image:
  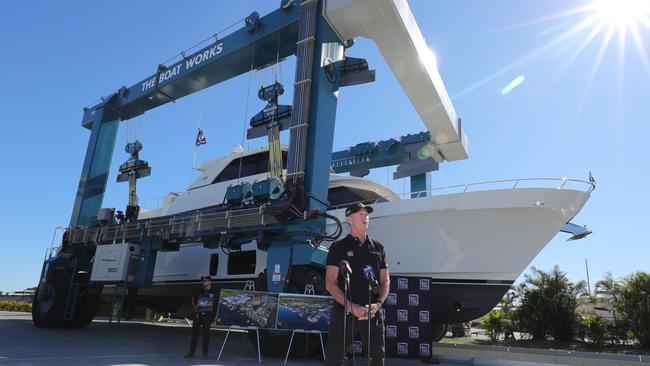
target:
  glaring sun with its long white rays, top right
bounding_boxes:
[452,0,650,102]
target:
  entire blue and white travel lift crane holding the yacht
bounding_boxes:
[32,0,467,354]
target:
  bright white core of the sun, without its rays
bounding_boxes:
[591,0,650,28]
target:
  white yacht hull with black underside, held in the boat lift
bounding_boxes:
[129,188,589,323]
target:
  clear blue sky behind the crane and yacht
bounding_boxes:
[0,0,650,291]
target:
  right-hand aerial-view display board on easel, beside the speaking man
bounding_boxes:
[277,293,334,332]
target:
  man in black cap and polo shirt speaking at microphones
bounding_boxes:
[325,203,390,366]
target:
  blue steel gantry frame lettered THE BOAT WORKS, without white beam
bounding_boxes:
[58,0,374,291]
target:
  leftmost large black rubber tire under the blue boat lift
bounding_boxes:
[32,270,71,328]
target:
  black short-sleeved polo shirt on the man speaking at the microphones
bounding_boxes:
[326,235,388,305]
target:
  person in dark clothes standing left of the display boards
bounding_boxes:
[185,276,217,359]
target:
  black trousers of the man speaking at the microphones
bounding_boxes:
[324,305,386,366]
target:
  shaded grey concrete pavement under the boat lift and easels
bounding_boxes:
[0,312,450,366]
